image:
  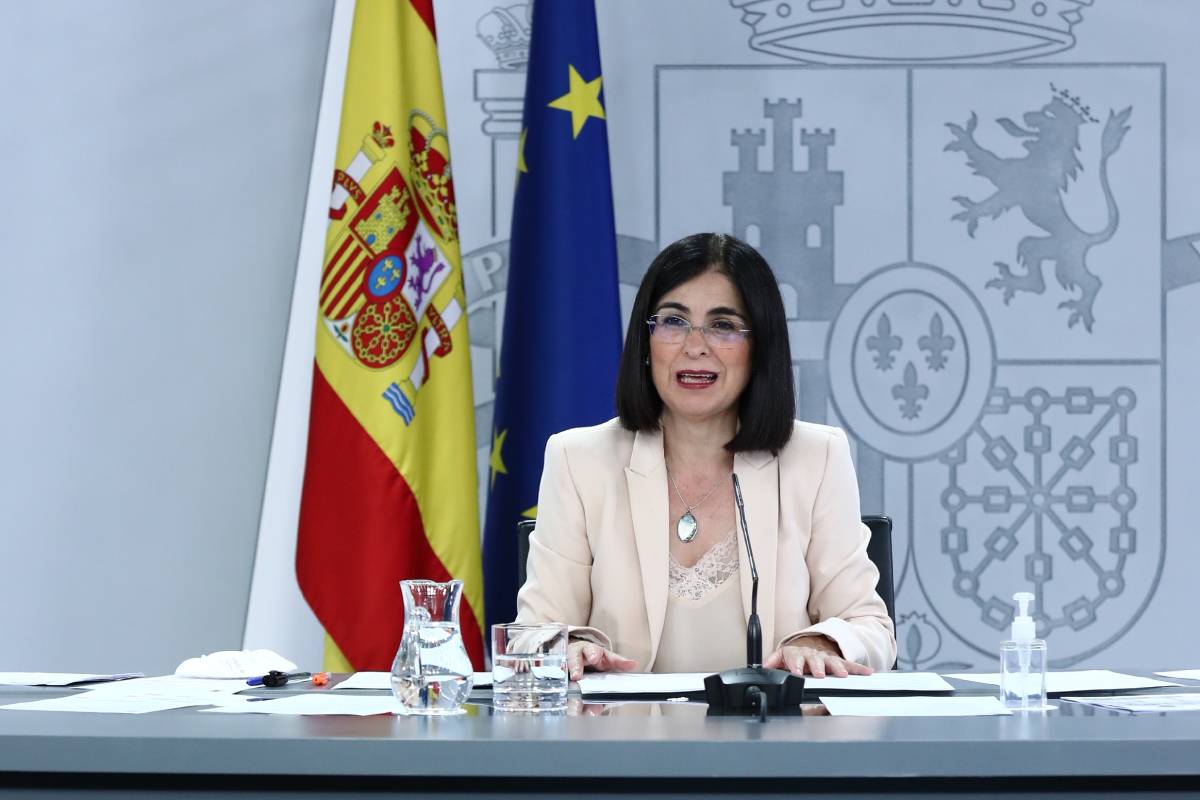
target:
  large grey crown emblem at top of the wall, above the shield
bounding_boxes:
[730,0,1092,64]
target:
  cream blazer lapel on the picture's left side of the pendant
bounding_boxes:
[625,432,670,672]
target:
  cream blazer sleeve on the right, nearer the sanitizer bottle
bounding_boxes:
[784,431,896,670]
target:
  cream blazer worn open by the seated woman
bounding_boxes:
[517,420,896,672]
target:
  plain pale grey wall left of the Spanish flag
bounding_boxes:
[0,0,332,672]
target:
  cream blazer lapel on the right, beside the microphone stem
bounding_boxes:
[733,452,779,658]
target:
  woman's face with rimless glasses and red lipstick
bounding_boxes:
[650,272,751,420]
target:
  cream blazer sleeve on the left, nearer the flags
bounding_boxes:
[517,434,612,649]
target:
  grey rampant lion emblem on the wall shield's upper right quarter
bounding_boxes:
[944,85,1133,331]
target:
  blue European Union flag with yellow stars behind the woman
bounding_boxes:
[484,1,620,638]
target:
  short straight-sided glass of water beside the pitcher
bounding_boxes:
[492,622,566,711]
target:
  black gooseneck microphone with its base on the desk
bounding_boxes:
[704,473,804,722]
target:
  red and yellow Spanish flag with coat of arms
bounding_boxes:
[296,0,484,670]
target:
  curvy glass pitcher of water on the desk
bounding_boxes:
[391,581,474,714]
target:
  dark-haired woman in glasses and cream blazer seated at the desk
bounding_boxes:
[517,234,895,679]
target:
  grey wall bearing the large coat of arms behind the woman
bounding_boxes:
[438,0,1200,672]
